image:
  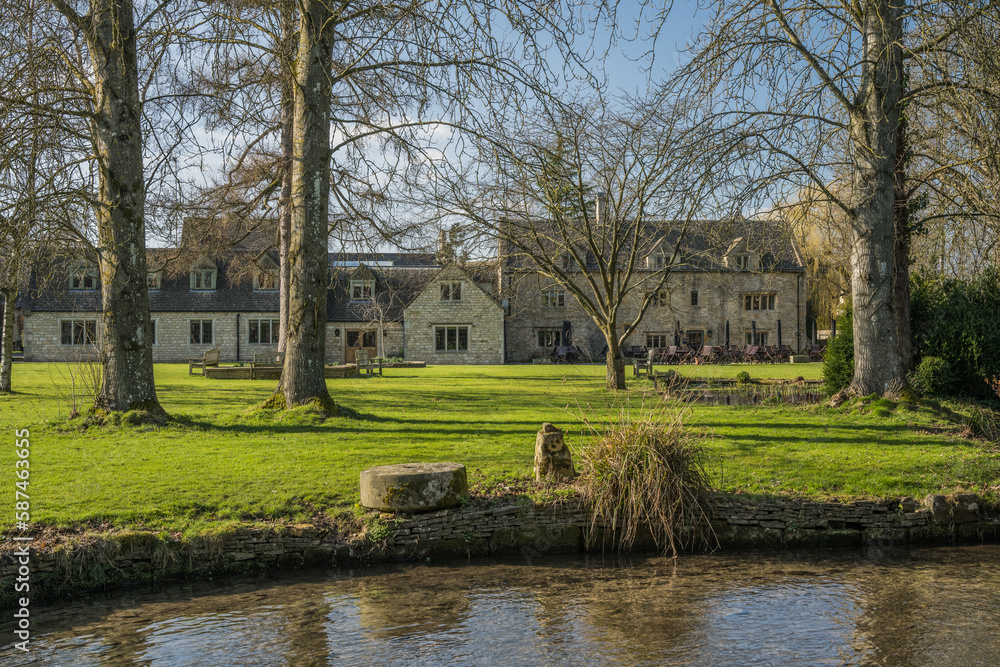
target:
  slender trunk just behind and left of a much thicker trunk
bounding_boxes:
[278,0,295,352]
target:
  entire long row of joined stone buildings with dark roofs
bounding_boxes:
[20,217,807,364]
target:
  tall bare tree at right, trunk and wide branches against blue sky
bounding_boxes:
[673,0,995,394]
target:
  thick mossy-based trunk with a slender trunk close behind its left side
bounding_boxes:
[279,0,336,412]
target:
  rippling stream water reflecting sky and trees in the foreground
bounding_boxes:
[0,546,1000,667]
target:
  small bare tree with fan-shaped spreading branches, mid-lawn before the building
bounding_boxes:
[433,99,725,389]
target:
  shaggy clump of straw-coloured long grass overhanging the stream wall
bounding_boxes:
[581,413,717,555]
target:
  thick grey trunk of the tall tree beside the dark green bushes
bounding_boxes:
[851,0,905,395]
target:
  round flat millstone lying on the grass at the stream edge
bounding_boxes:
[361,463,469,512]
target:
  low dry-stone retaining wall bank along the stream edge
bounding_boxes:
[0,494,1000,608]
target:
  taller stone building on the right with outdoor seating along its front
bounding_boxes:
[501,221,807,362]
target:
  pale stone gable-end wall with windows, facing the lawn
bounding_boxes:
[403,265,504,364]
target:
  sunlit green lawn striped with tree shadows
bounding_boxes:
[0,363,1000,532]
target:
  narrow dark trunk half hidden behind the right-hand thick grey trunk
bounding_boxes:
[892,111,913,371]
